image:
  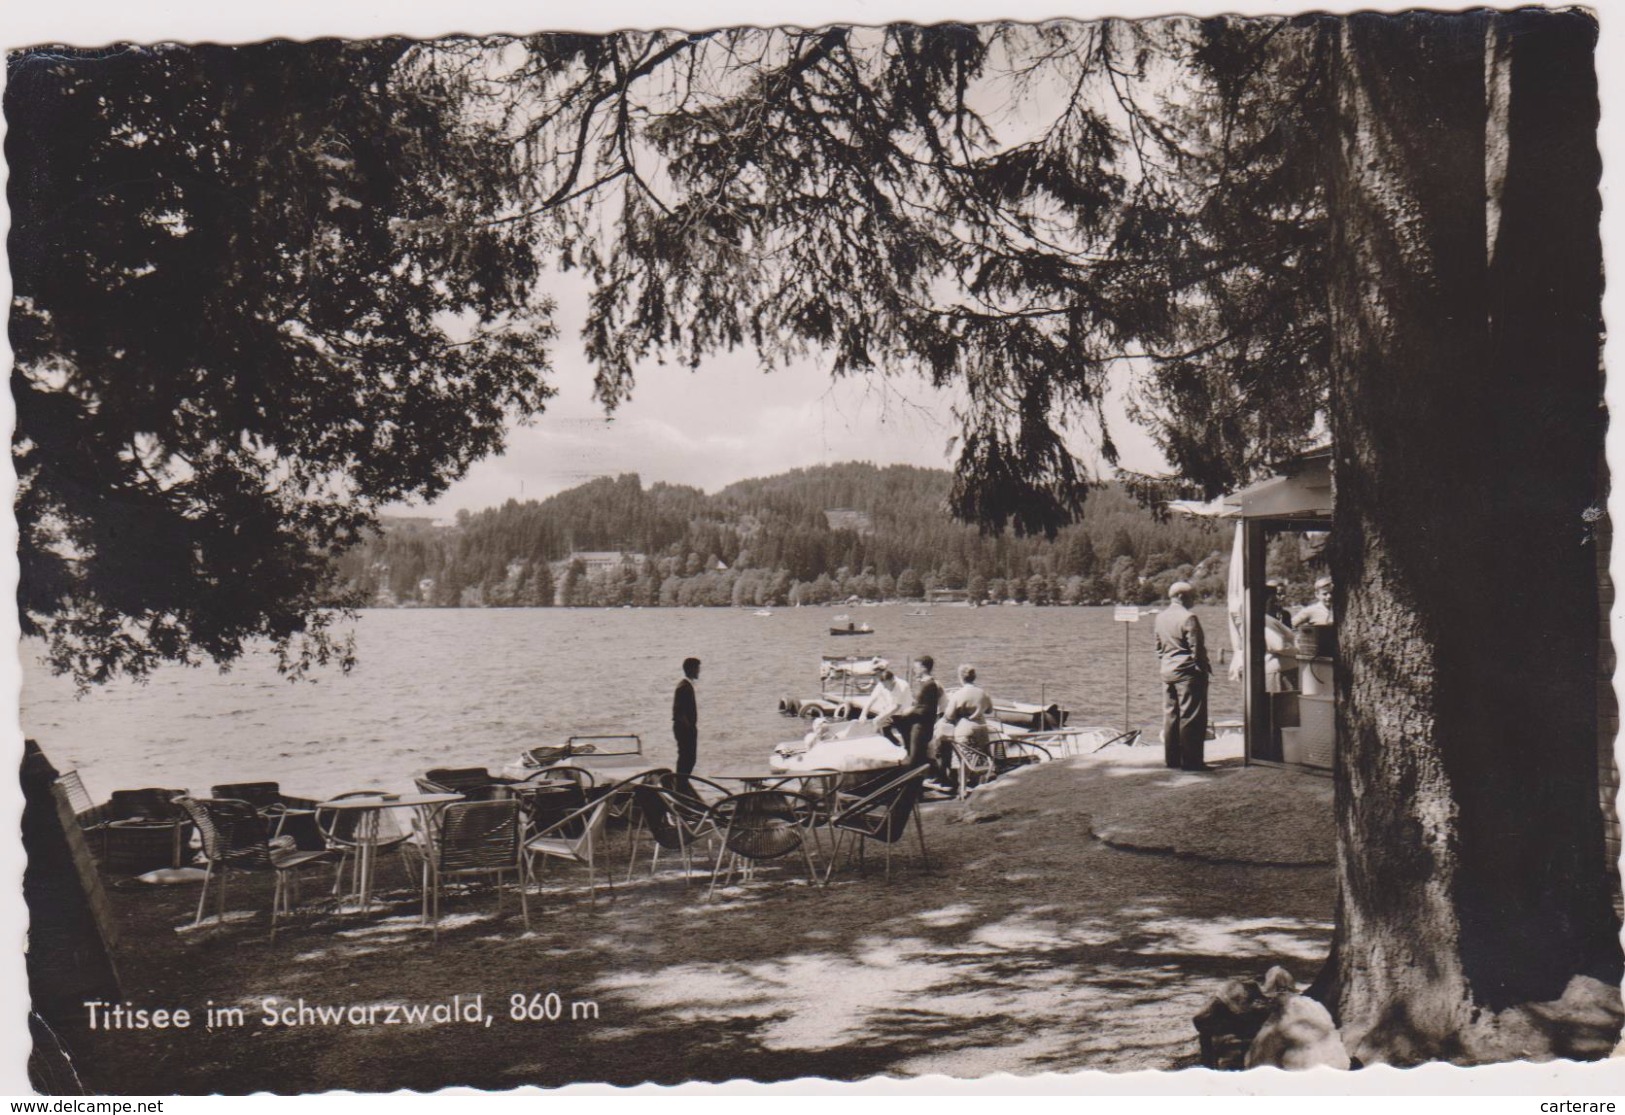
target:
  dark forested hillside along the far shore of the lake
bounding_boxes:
[326,463,1254,606]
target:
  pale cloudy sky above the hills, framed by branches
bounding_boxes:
[412,273,1162,518]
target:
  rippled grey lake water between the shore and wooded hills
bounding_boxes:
[21,605,1242,800]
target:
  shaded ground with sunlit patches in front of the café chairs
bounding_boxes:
[41,748,1334,1094]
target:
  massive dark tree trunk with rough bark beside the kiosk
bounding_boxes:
[1328,11,1620,1065]
